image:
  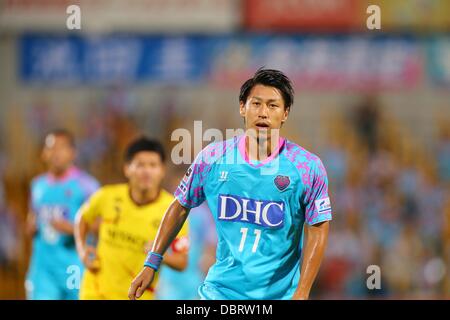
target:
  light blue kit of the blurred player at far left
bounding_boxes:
[26,167,99,300]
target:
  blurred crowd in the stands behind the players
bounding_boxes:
[0,90,450,299]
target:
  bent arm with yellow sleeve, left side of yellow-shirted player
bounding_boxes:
[74,189,103,272]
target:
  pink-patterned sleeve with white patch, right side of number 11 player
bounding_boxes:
[304,158,332,225]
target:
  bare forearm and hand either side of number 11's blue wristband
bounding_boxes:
[128,199,190,300]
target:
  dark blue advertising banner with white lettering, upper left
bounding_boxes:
[19,35,213,85]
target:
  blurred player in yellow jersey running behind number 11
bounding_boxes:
[75,138,189,300]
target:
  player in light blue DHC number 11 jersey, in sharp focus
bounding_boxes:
[129,69,332,300]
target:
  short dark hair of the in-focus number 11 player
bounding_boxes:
[239,68,294,110]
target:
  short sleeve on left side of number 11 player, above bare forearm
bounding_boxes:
[174,150,209,208]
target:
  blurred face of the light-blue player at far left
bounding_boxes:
[42,134,75,174]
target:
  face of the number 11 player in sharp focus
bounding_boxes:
[240,84,289,137]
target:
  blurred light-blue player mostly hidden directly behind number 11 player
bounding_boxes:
[156,202,217,300]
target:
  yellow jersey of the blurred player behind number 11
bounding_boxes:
[79,184,188,300]
